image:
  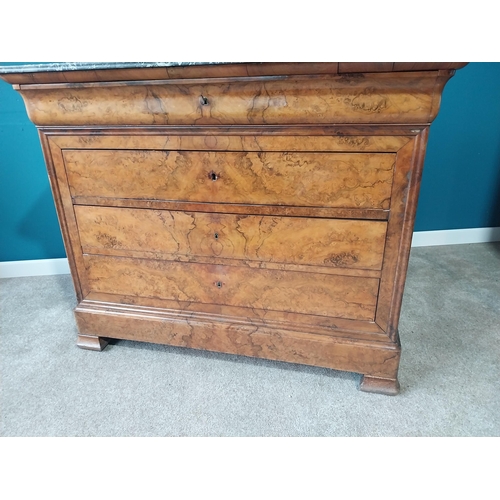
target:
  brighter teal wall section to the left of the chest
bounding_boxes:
[0,63,66,261]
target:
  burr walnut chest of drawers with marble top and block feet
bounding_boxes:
[0,63,463,394]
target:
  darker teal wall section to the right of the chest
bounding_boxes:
[415,63,500,231]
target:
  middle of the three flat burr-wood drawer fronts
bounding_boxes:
[75,206,387,269]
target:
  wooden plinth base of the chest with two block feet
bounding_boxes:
[75,301,401,395]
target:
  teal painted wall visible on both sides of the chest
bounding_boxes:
[0,63,500,261]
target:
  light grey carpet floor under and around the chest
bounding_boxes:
[0,243,500,436]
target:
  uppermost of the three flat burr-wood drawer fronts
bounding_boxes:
[63,150,395,209]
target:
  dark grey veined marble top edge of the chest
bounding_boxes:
[0,62,235,74]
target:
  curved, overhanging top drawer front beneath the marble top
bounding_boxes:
[16,71,453,126]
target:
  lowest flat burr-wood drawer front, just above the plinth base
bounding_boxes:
[84,255,379,321]
